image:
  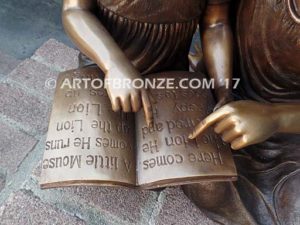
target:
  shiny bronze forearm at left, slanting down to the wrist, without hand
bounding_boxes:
[63,1,131,72]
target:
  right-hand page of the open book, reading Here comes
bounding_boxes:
[136,72,237,188]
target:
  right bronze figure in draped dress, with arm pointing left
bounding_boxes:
[187,0,300,224]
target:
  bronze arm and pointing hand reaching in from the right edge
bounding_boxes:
[190,101,300,150]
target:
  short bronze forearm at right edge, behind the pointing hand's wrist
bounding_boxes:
[274,104,300,134]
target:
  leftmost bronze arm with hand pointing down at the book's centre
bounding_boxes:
[62,0,152,124]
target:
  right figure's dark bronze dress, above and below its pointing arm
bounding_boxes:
[236,0,300,225]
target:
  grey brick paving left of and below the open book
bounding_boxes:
[0,39,216,225]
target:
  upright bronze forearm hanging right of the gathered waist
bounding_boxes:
[202,4,233,97]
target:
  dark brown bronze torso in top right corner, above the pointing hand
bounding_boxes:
[237,0,300,103]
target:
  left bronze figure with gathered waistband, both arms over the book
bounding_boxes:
[63,0,232,120]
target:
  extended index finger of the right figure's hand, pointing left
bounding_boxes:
[189,105,231,139]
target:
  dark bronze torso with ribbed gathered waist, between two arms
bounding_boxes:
[98,0,205,74]
